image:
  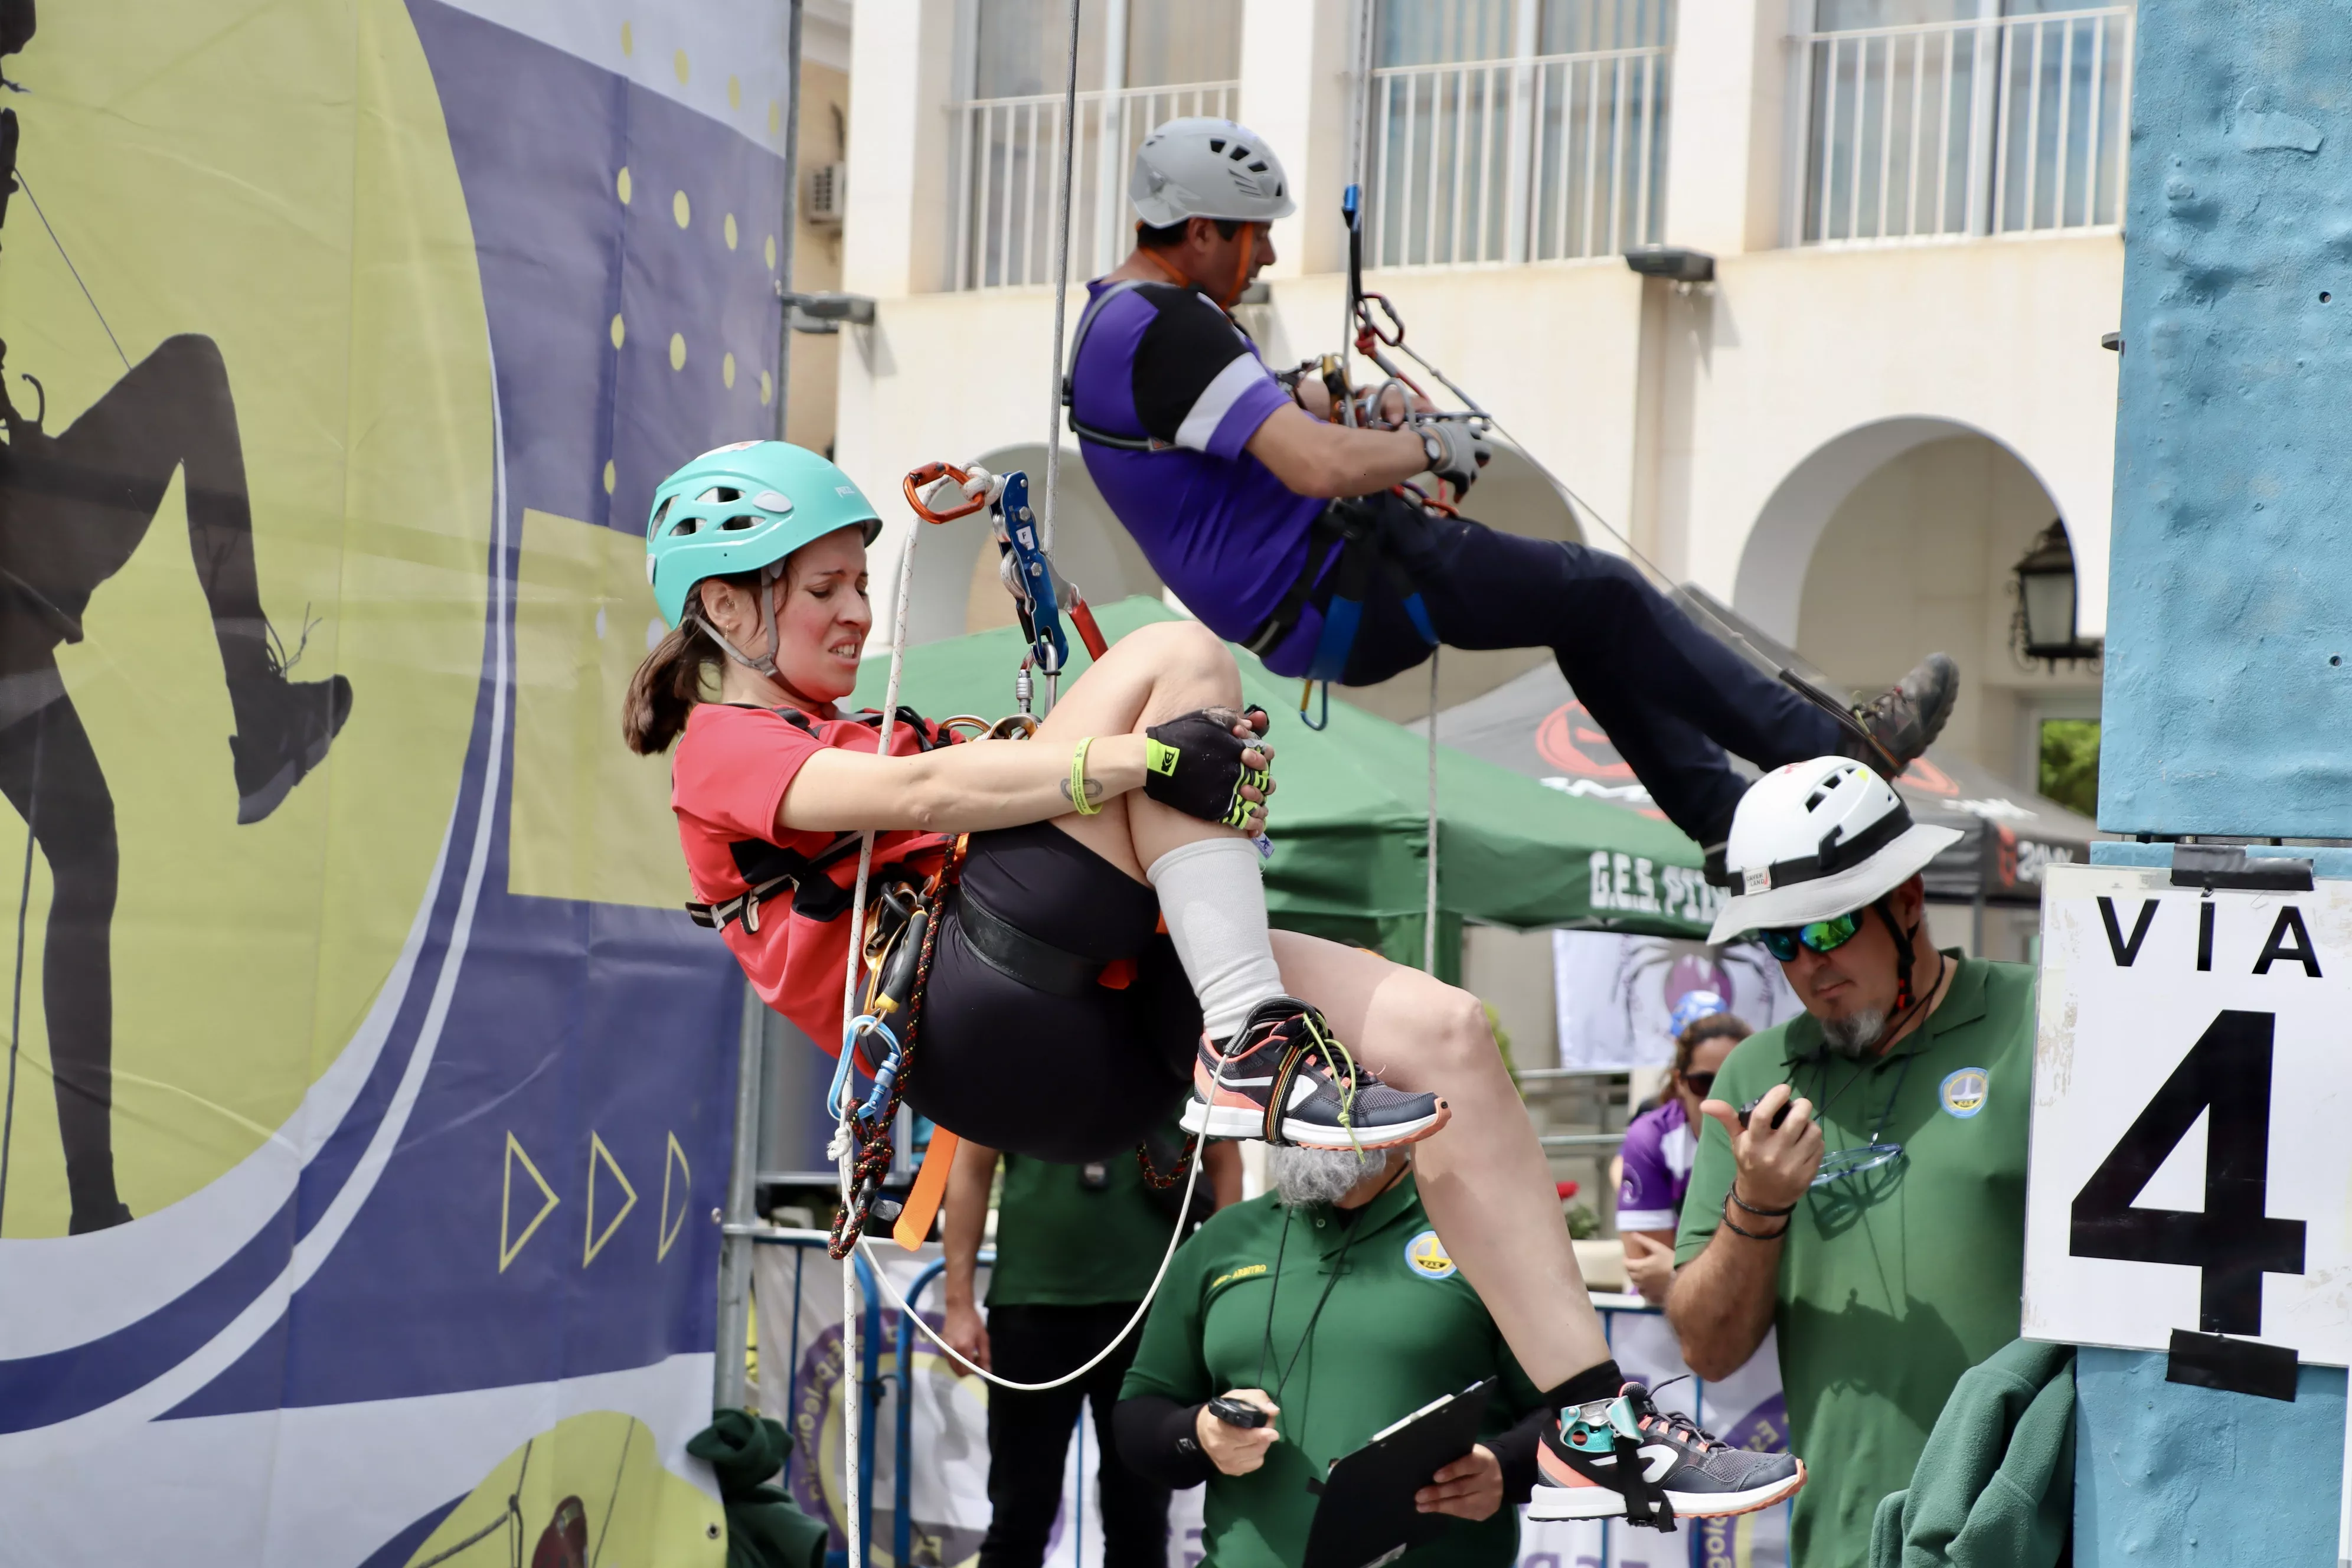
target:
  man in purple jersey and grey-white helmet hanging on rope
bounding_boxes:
[1063,120,1959,872]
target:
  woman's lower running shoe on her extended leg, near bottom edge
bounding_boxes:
[1527,1382,1804,1530]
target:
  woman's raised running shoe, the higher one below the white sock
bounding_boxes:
[1183,997,1453,1149]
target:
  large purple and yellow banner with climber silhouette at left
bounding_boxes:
[0,0,786,1568]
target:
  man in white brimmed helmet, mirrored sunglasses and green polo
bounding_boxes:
[1668,757,2034,1568]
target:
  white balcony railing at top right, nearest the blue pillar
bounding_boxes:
[1790,5,2135,244]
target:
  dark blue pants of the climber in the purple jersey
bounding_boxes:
[1317,496,1844,844]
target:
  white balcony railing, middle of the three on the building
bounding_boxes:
[1364,45,1672,268]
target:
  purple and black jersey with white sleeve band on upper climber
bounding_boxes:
[1070,280,1324,649]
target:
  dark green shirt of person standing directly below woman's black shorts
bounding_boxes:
[988,1133,1185,1307]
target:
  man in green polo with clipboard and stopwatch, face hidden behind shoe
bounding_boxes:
[1112,1145,1552,1568]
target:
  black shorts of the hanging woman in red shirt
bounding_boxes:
[906,823,1200,1164]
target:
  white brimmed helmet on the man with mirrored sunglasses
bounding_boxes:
[1707,757,1966,943]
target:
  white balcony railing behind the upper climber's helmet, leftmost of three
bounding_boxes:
[950,82,1242,289]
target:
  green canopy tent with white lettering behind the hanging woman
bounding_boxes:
[851,597,1719,980]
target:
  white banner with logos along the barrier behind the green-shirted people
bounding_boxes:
[755,1243,1788,1568]
